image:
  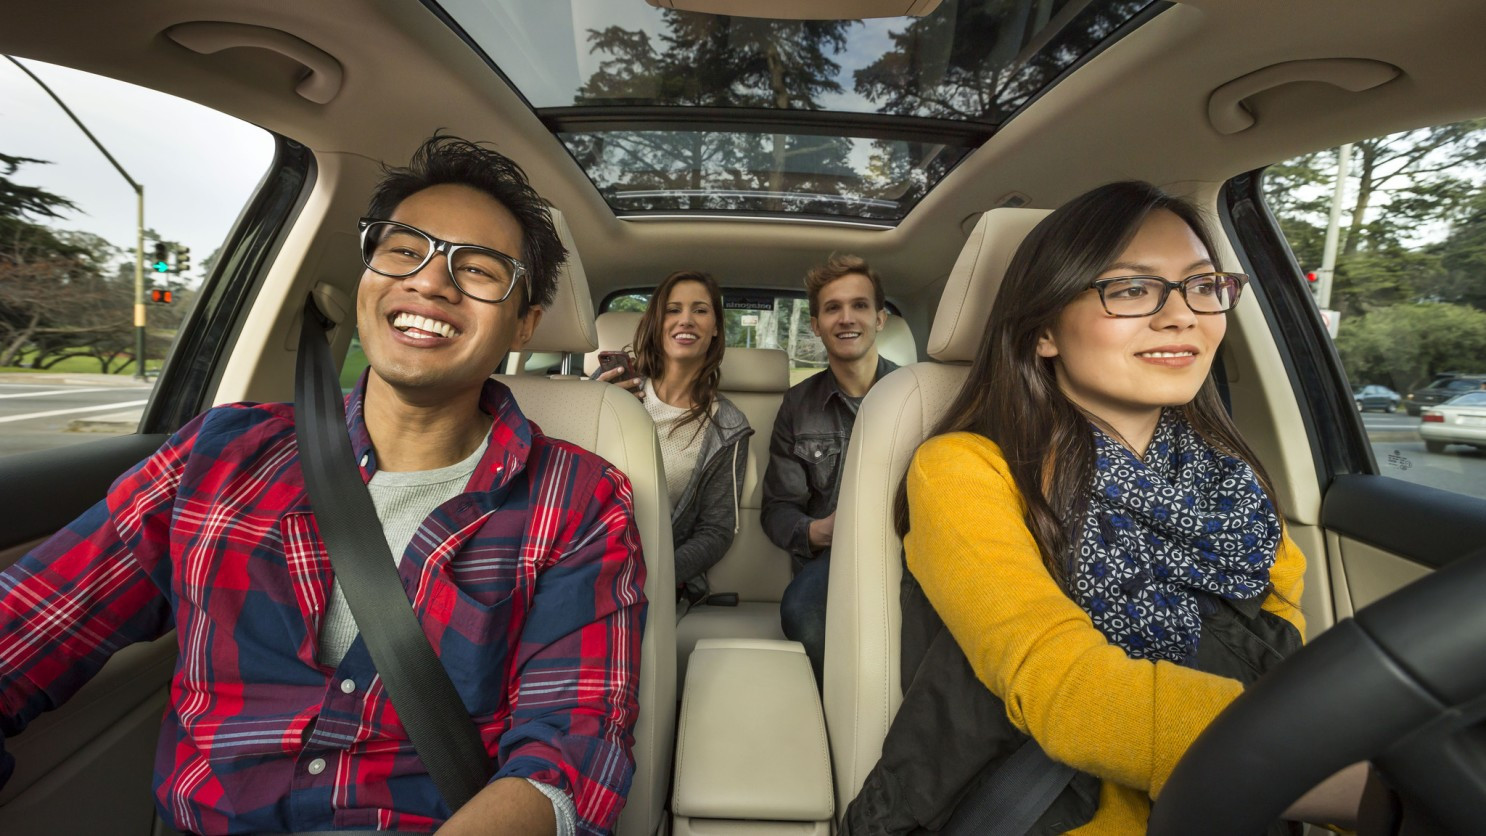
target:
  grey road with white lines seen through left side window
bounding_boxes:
[0,376,153,456]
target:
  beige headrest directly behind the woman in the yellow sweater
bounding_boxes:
[929,209,1052,362]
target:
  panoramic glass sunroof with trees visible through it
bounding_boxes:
[427,0,1169,224]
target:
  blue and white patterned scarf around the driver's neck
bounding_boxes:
[1071,410,1281,662]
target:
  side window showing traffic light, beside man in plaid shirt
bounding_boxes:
[0,61,273,456]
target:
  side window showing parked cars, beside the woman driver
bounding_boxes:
[1265,120,1486,497]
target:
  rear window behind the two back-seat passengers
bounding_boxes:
[603,290,867,385]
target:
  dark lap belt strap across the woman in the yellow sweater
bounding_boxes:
[941,738,1077,836]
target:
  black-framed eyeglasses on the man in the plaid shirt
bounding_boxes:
[360,218,531,301]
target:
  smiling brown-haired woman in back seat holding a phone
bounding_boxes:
[599,270,753,618]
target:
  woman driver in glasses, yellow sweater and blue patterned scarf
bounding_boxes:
[847,183,1360,833]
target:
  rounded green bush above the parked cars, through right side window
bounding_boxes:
[1336,303,1486,392]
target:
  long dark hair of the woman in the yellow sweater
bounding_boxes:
[893,181,1275,590]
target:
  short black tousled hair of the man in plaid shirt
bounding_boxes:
[367,132,568,316]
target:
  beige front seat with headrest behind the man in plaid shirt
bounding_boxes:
[496,211,676,836]
